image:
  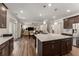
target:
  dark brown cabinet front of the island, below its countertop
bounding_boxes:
[39,38,72,56]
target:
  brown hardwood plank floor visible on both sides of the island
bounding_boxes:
[12,37,79,56]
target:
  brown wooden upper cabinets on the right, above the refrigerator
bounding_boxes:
[64,15,79,29]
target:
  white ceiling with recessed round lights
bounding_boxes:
[5,3,79,23]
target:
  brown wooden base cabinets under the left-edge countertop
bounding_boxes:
[0,38,13,56]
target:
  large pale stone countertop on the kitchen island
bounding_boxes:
[35,34,72,42]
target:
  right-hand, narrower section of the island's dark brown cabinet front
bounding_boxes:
[61,39,72,55]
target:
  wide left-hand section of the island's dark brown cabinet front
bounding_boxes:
[43,41,60,56]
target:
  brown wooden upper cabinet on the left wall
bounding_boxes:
[0,3,7,28]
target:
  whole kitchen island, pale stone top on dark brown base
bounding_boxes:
[35,34,72,56]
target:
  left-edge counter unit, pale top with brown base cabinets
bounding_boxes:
[0,36,13,56]
